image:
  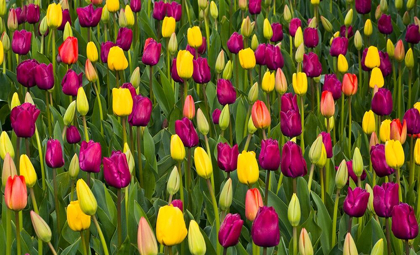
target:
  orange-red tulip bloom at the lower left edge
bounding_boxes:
[4,175,28,211]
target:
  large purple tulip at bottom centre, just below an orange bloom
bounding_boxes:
[251,206,280,247]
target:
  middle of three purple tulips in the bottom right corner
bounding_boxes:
[373,182,399,218]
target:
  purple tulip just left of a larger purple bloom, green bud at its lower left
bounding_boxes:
[79,140,102,173]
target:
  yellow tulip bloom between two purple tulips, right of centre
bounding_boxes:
[237,151,259,185]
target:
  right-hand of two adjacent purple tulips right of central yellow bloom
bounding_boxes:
[281,141,308,178]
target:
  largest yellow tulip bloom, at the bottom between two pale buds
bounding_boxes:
[156,205,187,246]
